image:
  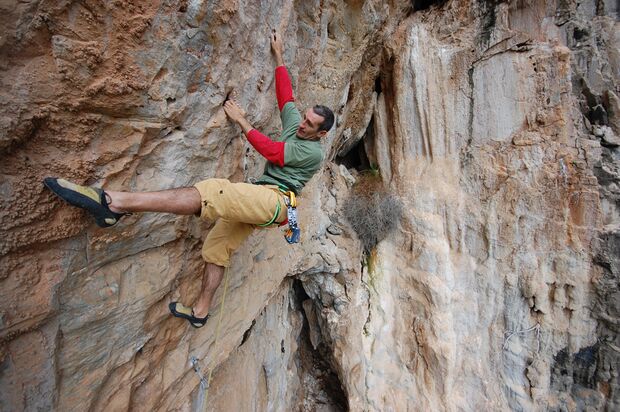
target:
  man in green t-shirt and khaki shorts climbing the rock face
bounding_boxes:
[44,31,334,328]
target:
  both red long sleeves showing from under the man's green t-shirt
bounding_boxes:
[246,66,295,167]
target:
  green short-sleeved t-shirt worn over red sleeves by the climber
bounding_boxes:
[256,102,323,194]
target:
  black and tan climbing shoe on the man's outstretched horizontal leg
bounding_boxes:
[43,177,127,227]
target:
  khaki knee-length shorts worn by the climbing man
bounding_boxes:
[194,179,286,267]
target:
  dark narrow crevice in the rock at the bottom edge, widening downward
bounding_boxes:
[293,279,349,411]
